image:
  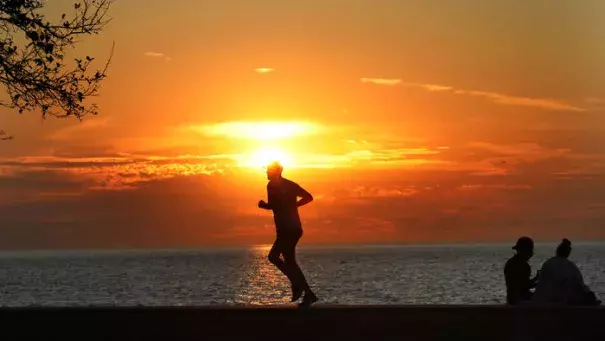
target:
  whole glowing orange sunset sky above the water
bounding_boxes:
[0,0,605,249]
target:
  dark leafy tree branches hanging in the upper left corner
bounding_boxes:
[0,0,113,122]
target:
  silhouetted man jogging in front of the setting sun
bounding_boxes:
[258,162,317,306]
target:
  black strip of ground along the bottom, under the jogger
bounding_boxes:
[0,305,605,341]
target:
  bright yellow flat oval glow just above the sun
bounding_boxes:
[199,121,318,140]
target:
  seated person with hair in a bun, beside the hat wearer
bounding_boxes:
[532,239,600,305]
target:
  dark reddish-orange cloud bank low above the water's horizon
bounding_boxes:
[0,142,605,248]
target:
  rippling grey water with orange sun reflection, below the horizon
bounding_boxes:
[0,243,605,306]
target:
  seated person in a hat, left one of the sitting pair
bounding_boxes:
[504,237,538,305]
